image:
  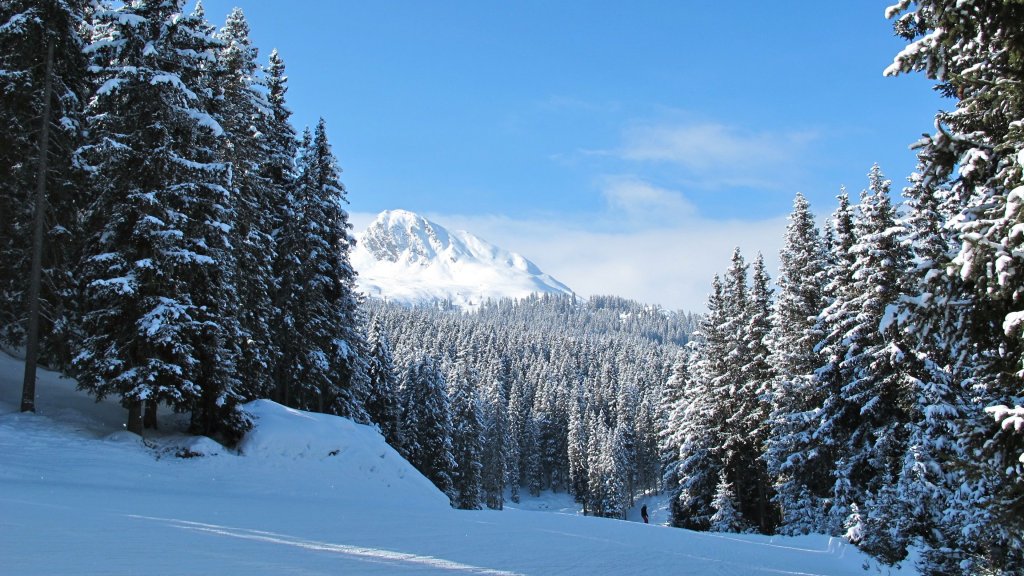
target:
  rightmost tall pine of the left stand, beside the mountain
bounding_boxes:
[279,119,367,420]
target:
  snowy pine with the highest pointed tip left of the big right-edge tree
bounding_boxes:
[817,165,908,529]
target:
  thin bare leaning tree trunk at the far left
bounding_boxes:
[22,39,53,412]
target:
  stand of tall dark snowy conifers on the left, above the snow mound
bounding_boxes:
[0,0,369,439]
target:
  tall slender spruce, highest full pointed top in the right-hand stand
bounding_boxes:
[838,165,915,562]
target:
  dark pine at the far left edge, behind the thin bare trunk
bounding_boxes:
[0,0,88,368]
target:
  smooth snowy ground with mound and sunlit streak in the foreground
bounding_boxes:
[0,353,913,576]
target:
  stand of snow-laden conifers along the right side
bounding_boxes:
[662,0,1024,574]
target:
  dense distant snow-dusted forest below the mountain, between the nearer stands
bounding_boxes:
[367,295,695,518]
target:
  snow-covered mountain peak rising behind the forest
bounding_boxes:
[351,210,572,310]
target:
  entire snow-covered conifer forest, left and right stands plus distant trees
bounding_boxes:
[0,0,1024,574]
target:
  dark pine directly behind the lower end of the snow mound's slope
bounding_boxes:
[400,356,456,496]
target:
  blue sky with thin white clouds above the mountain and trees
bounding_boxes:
[195,0,952,310]
